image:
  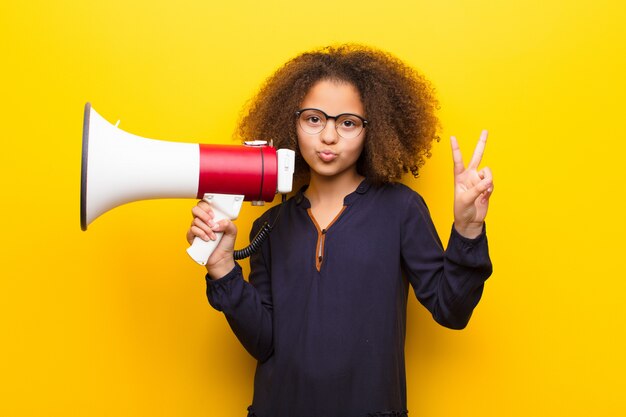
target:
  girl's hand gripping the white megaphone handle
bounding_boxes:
[187,200,237,279]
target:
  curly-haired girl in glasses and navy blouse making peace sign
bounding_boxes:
[187,45,493,417]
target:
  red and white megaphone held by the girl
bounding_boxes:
[80,103,295,265]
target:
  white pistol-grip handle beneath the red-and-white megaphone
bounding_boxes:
[187,194,244,265]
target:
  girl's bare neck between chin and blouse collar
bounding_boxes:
[305,171,365,206]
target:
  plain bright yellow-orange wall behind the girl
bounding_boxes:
[0,0,626,417]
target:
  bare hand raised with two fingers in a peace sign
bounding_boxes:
[450,130,493,238]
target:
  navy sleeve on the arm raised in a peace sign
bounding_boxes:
[402,190,492,329]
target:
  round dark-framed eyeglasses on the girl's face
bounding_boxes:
[296,109,369,139]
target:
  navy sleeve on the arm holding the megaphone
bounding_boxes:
[206,218,273,362]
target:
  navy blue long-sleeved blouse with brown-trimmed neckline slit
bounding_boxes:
[207,180,492,417]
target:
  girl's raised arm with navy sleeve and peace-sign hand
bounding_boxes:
[402,131,493,329]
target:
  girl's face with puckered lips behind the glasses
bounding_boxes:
[296,80,365,178]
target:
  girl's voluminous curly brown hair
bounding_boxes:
[238,44,440,184]
